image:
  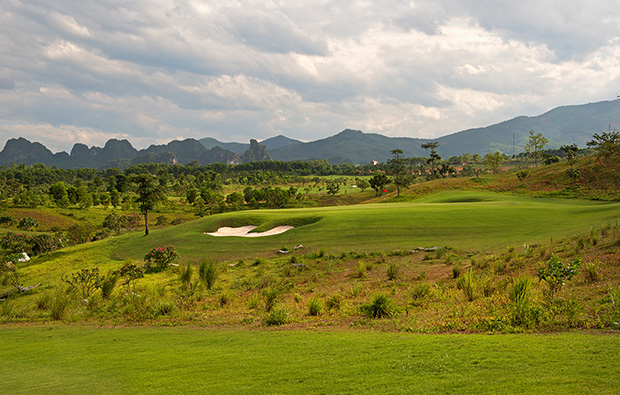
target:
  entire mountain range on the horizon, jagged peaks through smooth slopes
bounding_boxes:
[0,100,620,169]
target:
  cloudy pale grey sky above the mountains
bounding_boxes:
[0,0,620,152]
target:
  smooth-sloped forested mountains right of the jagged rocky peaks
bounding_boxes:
[269,100,620,164]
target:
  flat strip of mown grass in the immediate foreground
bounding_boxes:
[0,325,620,394]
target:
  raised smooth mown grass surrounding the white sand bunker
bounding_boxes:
[116,191,620,260]
